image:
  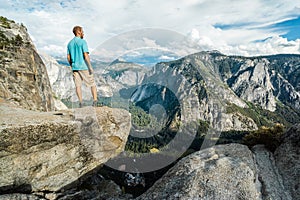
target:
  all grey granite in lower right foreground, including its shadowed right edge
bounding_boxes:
[137,124,300,200]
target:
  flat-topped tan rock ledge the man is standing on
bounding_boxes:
[0,102,131,198]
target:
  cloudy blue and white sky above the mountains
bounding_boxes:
[0,0,300,62]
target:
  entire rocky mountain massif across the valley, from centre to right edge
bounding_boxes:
[131,52,300,131]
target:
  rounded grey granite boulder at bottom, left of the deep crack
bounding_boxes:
[137,144,260,200]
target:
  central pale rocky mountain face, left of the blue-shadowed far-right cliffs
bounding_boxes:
[131,54,257,131]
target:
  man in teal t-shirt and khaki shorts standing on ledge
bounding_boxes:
[67,26,97,108]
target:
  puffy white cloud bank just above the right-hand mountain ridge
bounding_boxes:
[185,25,300,56]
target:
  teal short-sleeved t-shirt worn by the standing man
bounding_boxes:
[67,37,89,70]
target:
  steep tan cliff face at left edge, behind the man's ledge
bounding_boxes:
[0,17,54,111]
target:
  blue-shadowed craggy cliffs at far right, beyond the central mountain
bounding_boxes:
[220,55,300,112]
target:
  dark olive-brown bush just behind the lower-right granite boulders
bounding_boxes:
[243,124,284,152]
